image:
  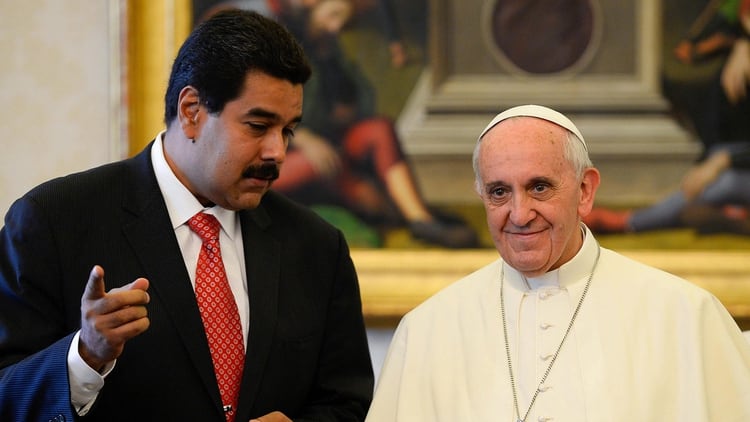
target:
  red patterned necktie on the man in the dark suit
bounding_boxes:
[188,213,245,422]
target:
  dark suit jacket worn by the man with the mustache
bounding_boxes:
[0,143,373,422]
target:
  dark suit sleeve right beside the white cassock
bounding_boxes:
[292,232,373,422]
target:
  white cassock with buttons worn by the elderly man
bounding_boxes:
[367,229,750,422]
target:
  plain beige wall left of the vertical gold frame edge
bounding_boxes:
[0,0,118,215]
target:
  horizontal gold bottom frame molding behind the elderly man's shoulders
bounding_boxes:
[351,249,750,330]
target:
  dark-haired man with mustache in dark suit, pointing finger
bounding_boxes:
[0,11,373,422]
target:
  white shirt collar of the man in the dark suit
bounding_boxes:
[151,131,237,238]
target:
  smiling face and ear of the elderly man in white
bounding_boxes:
[478,117,599,277]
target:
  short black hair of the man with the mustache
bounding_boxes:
[164,10,311,126]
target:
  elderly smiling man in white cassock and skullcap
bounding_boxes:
[367,105,750,422]
